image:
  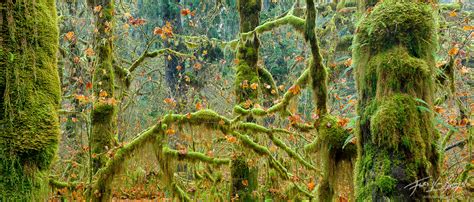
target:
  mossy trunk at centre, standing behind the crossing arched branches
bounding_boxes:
[231,0,262,201]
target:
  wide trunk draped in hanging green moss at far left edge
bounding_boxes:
[0,0,61,201]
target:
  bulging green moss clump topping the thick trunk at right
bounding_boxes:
[355,1,437,58]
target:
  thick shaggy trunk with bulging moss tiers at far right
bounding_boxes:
[353,1,439,201]
